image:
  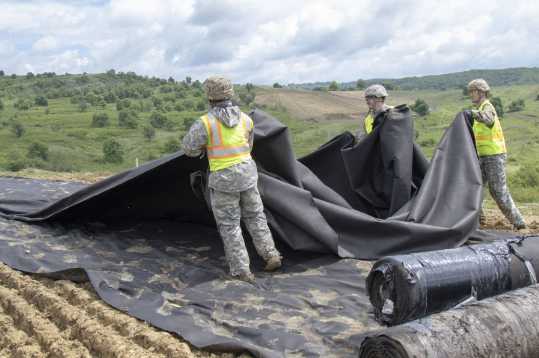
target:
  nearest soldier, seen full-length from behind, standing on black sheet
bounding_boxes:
[182,76,281,282]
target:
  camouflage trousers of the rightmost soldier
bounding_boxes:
[479,154,524,226]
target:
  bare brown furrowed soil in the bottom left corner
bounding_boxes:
[0,264,248,358]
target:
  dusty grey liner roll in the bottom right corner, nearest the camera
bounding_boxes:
[358,285,539,358]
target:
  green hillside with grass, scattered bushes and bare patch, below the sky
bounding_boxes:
[0,71,539,203]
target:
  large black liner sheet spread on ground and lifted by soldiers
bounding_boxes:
[0,107,508,357]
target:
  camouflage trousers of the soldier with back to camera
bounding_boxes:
[210,185,280,276]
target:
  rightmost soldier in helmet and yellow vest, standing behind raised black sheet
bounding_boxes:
[468,78,526,229]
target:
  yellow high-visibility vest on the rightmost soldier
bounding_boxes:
[473,100,507,157]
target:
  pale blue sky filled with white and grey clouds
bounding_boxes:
[0,0,539,84]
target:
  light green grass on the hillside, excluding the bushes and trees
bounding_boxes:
[0,74,539,213]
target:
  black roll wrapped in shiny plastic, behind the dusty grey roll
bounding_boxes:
[367,237,539,325]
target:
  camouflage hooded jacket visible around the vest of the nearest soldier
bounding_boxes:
[182,100,258,193]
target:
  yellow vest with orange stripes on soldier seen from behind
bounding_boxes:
[200,113,254,172]
